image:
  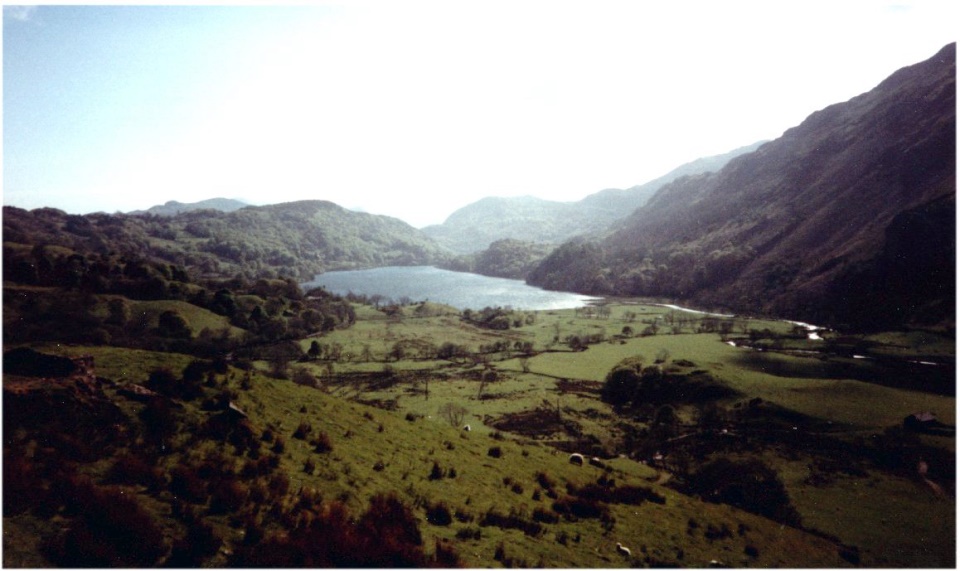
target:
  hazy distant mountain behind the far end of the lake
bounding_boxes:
[422,143,760,254]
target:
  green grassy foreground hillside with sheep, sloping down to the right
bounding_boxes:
[225,358,842,567]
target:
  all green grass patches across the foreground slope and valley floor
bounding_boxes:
[5,302,955,567]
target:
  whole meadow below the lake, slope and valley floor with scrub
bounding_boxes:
[4,300,955,567]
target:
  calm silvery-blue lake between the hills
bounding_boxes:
[303,266,595,310]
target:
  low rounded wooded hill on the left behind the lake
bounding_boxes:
[3,200,450,279]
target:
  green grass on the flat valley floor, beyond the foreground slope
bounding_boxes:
[272,305,955,566]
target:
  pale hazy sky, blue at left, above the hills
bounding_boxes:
[3,0,960,227]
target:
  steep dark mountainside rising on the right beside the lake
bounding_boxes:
[529,44,956,328]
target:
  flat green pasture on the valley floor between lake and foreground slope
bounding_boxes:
[276,304,956,566]
